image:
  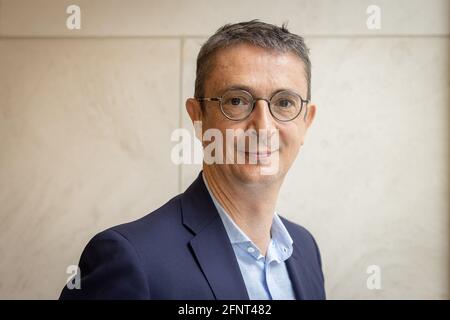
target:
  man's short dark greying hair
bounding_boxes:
[195,19,311,100]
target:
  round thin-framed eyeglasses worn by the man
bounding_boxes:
[196,89,309,122]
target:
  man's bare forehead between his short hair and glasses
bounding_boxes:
[205,44,307,95]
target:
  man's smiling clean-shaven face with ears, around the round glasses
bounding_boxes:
[187,44,315,184]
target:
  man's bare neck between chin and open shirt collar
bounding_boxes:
[203,164,281,256]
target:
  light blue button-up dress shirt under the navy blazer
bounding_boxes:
[202,173,295,300]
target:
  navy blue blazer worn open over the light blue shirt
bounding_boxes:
[60,173,325,300]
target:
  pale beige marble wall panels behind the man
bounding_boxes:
[0,0,450,299]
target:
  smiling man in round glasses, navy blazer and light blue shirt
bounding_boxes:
[61,20,325,299]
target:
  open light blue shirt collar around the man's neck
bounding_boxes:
[202,172,293,262]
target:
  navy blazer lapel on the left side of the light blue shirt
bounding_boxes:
[181,172,249,300]
